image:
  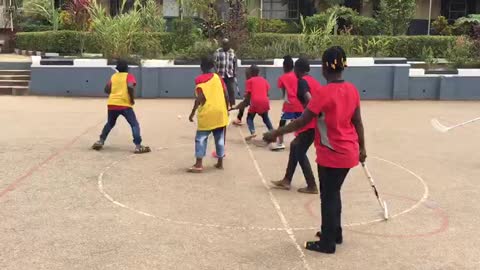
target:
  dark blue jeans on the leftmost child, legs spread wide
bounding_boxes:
[100,108,142,145]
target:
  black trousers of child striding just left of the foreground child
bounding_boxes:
[285,128,317,187]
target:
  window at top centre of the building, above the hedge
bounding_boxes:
[261,0,299,19]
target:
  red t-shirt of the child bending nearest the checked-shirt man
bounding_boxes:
[246,76,270,114]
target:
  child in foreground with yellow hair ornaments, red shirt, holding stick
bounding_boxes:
[264,47,367,253]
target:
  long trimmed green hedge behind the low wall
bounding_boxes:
[16,31,457,59]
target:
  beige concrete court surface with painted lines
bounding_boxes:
[0,96,480,270]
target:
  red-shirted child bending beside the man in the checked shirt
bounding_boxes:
[232,65,273,140]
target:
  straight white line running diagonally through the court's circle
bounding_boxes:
[238,129,311,270]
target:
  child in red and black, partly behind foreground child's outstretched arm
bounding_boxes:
[272,58,320,194]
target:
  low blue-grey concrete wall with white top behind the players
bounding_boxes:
[30,58,480,100]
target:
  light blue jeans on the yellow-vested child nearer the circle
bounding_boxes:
[195,127,225,158]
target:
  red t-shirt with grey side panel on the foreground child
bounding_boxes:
[307,82,360,168]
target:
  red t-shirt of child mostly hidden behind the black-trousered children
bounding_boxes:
[278,71,303,112]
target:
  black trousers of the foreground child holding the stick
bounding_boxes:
[318,166,350,245]
